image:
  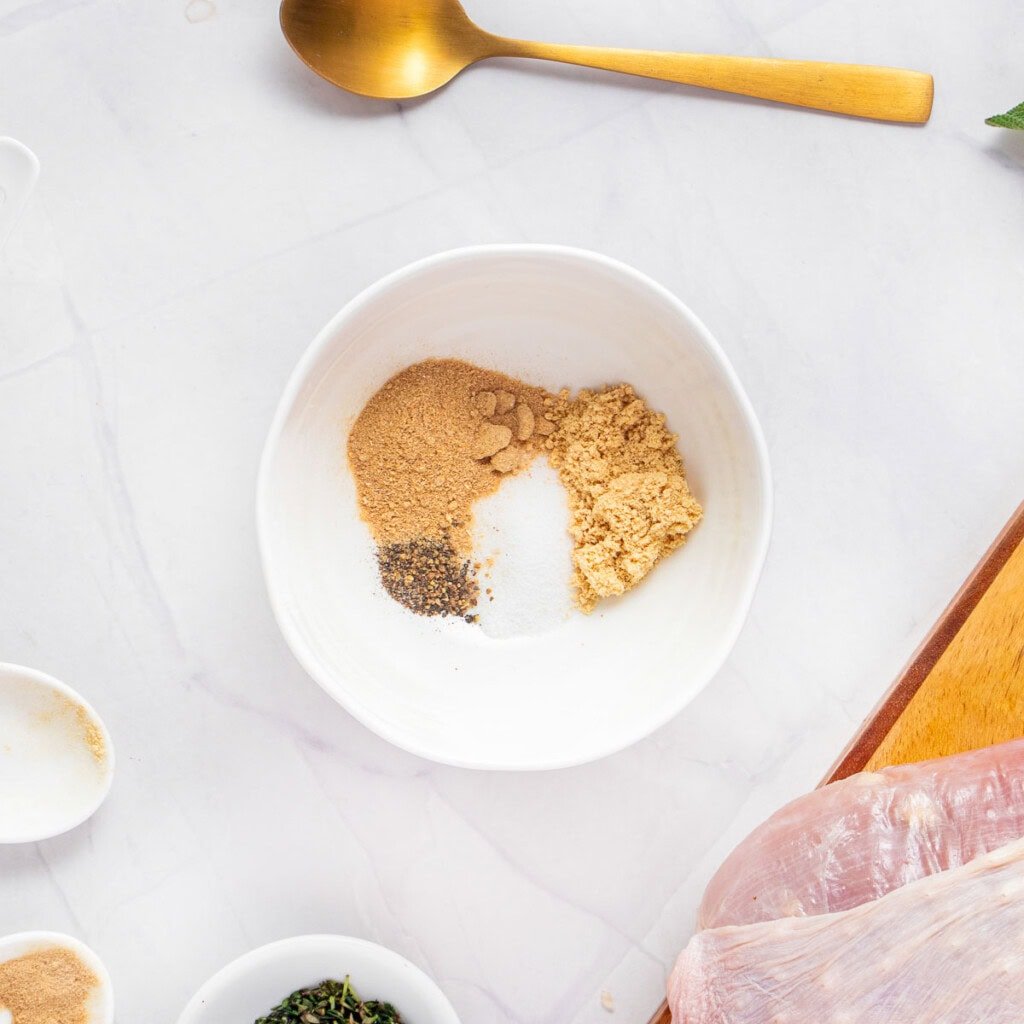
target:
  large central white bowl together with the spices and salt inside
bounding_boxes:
[258,246,771,769]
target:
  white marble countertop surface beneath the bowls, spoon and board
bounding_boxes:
[0,0,1024,1024]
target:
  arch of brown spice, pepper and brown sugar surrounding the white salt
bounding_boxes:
[348,359,702,623]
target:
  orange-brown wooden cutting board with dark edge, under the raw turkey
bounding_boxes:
[650,505,1024,1024]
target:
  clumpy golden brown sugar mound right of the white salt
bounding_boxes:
[546,384,703,612]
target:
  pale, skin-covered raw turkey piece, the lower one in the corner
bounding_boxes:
[669,841,1024,1024]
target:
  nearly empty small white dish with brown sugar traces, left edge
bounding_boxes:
[0,663,114,844]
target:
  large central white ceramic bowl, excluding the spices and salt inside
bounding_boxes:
[257,246,771,769]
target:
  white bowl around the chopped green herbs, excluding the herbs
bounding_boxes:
[178,935,459,1024]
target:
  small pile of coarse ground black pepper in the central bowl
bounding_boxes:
[377,535,480,623]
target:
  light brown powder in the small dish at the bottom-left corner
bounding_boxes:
[0,946,99,1024]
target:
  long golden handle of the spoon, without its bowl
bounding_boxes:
[487,36,934,124]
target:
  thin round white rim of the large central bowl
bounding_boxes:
[256,243,774,771]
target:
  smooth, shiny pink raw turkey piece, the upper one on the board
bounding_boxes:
[699,740,1024,928]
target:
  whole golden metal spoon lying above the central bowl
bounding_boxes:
[281,0,933,124]
